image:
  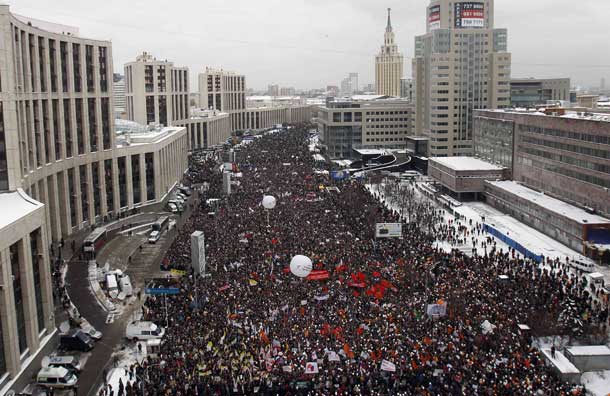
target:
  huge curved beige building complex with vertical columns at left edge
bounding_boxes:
[0,5,187,381]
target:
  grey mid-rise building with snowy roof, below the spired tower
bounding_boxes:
[317,95,413,159]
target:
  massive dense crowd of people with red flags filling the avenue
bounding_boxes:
[113,127,608,395]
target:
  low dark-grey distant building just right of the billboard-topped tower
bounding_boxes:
[510,78,570,107]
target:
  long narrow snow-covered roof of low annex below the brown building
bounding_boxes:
[487,181,610,224]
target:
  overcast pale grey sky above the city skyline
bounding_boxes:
[8,0,610,89]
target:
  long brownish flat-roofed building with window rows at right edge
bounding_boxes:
[475,109,610,216]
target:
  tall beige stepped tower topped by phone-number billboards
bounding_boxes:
[413,0,511,157]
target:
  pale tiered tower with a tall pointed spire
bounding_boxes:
[375,8,404,96]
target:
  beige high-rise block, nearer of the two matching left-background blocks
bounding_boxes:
[125,52,189,126]
